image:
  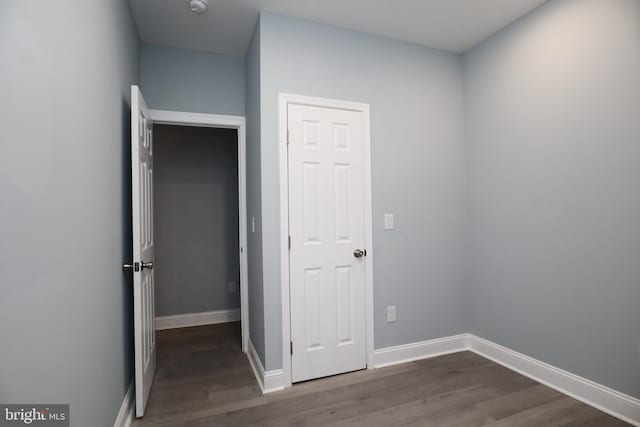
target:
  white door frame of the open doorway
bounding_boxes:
[149,110,249,353]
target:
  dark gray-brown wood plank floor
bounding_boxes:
[133,323,627,427]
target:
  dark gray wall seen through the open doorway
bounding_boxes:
[153,125,240,316]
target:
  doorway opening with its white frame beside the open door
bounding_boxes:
[150,110,249,353]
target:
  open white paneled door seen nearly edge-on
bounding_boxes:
[131,85,156,418]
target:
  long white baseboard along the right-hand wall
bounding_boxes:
[469,335,640,426]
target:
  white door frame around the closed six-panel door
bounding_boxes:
[278,93,374,387]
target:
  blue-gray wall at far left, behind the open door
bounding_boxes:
[0,0,138,427]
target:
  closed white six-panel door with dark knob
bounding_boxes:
[287,104,366,382]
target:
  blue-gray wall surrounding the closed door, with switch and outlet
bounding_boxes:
[260,14,466,370]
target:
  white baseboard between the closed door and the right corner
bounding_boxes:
[373,334,469,368]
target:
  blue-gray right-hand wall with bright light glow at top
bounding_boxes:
[465,0,640,397]
